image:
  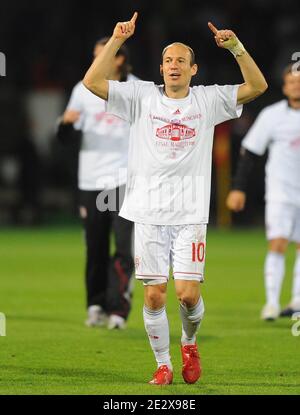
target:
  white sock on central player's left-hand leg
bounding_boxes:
[143,306,172,369]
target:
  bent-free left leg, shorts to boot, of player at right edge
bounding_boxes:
[261,202,292,321]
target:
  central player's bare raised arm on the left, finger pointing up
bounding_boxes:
[83,12,138,100]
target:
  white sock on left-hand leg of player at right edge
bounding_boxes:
[265,251,285,307]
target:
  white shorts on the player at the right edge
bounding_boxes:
[265,201,300,242]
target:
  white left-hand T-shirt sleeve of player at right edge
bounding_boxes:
[242,109,272,156]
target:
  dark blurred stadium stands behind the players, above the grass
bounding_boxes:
[0,0,300,225]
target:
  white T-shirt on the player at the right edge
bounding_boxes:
[242,100,300,207]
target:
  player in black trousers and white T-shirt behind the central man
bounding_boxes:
[58,38,137,329]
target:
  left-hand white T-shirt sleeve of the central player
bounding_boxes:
[106,81,137,123]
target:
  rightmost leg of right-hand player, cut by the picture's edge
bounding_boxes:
[280,207,300,317]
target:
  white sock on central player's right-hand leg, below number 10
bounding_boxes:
[180,297,204,345]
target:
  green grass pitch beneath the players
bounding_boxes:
[0,226,300,395]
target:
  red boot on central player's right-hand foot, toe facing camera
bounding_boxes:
[181,344,201,383]
